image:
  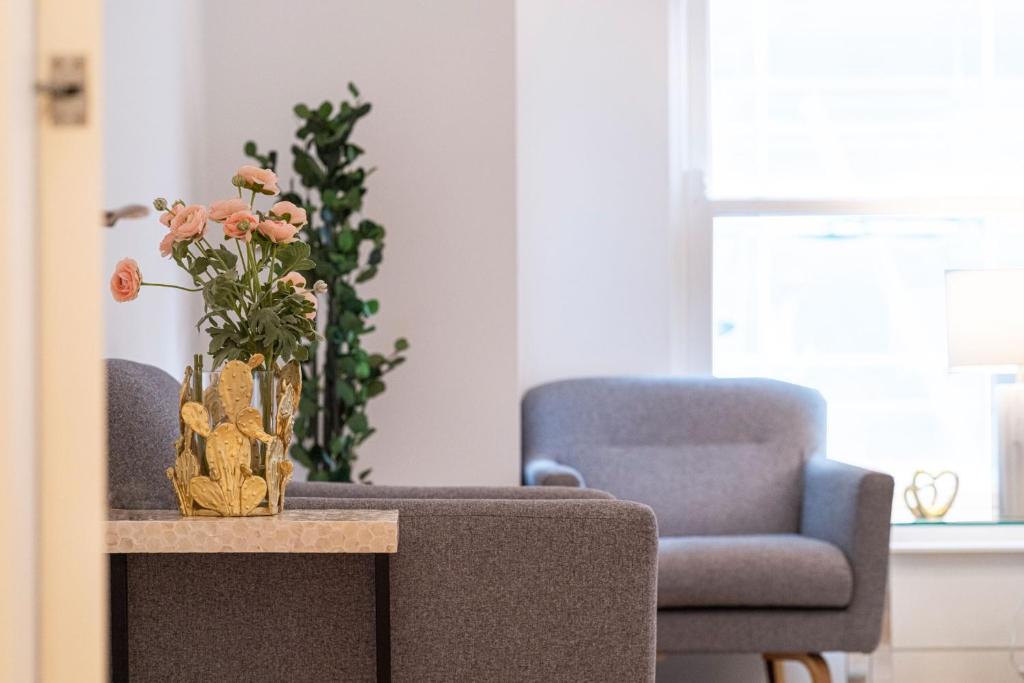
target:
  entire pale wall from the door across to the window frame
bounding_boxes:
[106,0,672,491]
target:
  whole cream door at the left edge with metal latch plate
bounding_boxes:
[0,0,108,683]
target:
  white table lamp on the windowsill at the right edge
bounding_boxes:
[946,270,1024,518]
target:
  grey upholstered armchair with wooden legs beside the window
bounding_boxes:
[522,379,893,681]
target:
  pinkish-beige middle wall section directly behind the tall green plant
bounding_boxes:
[197,0,519,484]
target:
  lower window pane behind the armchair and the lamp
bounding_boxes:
[713,216,1024,519]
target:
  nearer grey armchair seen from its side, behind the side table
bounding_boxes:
[106,360,657,683]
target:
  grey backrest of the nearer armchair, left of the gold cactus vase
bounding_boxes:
[106,358,179,509]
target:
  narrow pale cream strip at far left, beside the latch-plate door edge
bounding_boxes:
[0,0,38,681]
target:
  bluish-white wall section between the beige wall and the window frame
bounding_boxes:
[516,0,672,388]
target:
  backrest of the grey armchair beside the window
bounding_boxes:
[522,378,825,536]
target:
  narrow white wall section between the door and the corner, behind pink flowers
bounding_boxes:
[103,0,202,377]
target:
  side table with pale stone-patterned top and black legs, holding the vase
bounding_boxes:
[106,510,398,683]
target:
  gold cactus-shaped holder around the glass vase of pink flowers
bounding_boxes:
[167,354,302,517]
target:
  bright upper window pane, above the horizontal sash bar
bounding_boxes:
[708,0,1024,199]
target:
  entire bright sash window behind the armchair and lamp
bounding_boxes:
[686,0,1024,519]
